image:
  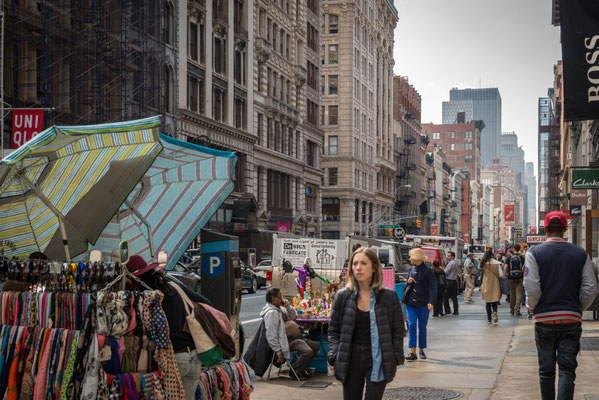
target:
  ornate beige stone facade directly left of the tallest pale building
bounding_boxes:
[252,0,324,236]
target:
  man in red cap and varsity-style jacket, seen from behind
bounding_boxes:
[524,211,597,400]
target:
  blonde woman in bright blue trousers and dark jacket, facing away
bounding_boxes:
[406,248,437,361]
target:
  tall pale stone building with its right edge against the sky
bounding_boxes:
[324,0,398,238]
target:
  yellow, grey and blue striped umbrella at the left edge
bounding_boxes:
[0,117,162,260]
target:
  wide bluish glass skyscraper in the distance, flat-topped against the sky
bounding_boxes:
[443,88,501,167]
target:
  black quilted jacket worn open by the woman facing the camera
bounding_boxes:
[327,288,406,383]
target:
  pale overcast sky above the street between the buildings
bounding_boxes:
[394,0,561,175]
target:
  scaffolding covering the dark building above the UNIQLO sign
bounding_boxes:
[2,0,166,146]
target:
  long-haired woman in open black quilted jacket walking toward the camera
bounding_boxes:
[327,247,405,400]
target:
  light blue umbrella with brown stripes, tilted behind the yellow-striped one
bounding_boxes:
[89,135,237,267]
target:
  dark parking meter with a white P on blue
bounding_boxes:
[200,229,242,318]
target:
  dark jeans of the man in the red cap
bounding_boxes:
[535,322,582,400]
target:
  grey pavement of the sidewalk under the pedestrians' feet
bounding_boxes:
[246,289,599,400]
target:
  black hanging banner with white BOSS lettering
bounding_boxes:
[560,0,599,121]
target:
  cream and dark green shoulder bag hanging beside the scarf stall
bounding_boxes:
[170,282,223,367]
